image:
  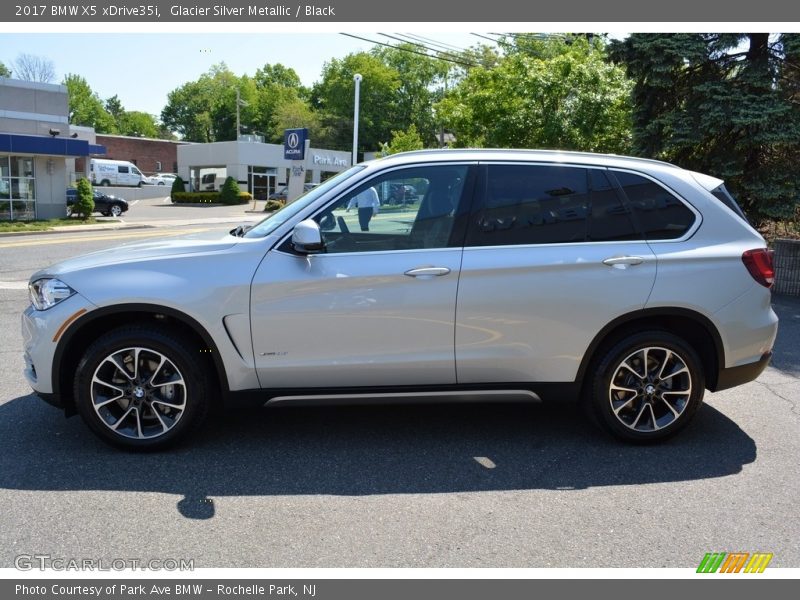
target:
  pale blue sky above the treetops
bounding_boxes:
[0,30,491,116]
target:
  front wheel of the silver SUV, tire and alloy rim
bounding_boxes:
[73,326,212,451]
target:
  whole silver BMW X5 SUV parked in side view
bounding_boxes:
[22,150,777,449]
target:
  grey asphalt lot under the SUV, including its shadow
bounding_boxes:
[0,224,800,568]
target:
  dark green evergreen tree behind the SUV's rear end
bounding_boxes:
[611,33,800,221]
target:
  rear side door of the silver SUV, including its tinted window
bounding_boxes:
[456,163,656,383]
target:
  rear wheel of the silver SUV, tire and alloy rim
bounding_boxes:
[584,330,705,443]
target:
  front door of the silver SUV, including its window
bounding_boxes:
[251,164,472,388]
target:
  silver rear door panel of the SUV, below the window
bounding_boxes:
[456,242,656,383]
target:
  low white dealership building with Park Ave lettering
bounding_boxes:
[177,135,351,200]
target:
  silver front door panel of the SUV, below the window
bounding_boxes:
[252,248,461,388]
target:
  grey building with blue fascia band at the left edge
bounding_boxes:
[0,77,105,221]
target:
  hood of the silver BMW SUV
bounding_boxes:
[31,231,241,281]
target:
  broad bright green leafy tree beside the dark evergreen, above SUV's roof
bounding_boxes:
[436,38,631,153]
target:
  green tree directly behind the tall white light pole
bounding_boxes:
[311,52,400,151]
